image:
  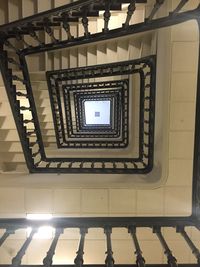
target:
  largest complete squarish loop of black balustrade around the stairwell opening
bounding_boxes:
[0,53,155,173]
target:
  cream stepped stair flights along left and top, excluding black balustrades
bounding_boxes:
[0,1,156,173]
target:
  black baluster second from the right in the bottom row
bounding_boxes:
[153,227,178,267]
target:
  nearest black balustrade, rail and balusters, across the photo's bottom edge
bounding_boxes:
[0,215,200,267]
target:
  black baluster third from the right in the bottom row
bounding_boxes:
[128,226,145,267]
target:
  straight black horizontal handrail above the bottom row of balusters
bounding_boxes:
[0,216,195,229]
